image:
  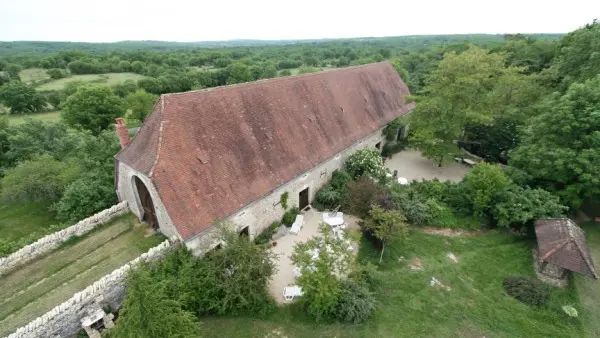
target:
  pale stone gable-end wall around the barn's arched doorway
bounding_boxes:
[117,162,181,240]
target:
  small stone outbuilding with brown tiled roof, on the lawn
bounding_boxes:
[534,218,598,286]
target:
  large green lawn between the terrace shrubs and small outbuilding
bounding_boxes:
[201,230,582,338]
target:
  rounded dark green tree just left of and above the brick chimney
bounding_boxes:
[61,85,122,134]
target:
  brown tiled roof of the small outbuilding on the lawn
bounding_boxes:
[535,218,598,278]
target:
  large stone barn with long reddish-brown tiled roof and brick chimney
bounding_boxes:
[115,62,413,253]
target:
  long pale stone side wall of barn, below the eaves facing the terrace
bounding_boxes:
[186,128,385,254]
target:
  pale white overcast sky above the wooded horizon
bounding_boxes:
[0,0,600,42]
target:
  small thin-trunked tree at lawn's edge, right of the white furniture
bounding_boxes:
[363,205,408,263]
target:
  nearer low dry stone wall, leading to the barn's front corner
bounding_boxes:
[8,240,171,338]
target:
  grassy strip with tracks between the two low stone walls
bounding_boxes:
[0,214,163,337]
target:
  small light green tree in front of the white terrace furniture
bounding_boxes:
[291,226,351,321]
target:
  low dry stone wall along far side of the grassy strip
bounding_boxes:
[0,201,129,275]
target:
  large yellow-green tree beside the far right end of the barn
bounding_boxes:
[411,47,523,165]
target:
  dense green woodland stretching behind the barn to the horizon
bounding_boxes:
[0,22,600,253]
